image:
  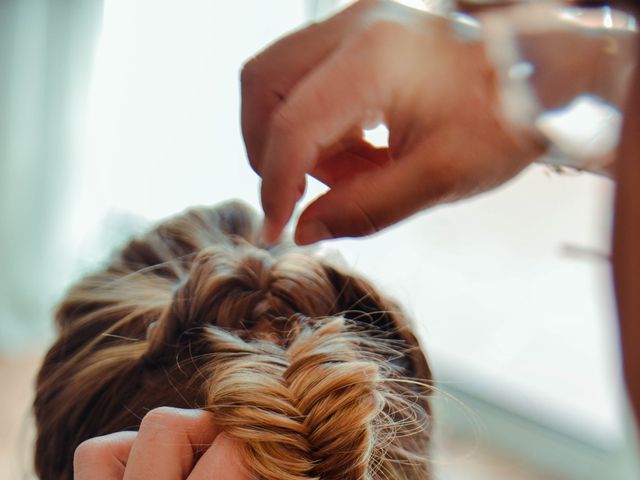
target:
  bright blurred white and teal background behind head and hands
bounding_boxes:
[0,0,640,480]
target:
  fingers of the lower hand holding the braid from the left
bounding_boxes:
[73,407,253,480]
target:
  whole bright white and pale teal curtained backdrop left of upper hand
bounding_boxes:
[0,0,318,354]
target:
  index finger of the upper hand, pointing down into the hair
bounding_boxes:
[261,28,391,242]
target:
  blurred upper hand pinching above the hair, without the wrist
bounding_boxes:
[242,0,538,244]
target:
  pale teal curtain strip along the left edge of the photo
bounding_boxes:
[0,0,102,353]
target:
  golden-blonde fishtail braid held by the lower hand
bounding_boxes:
[208,318,391,480]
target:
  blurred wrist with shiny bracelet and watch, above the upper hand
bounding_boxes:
[476,1,638,173]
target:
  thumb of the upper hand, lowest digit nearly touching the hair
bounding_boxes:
[295,147,458,245]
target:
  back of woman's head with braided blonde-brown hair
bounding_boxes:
[34,203,430,480]
